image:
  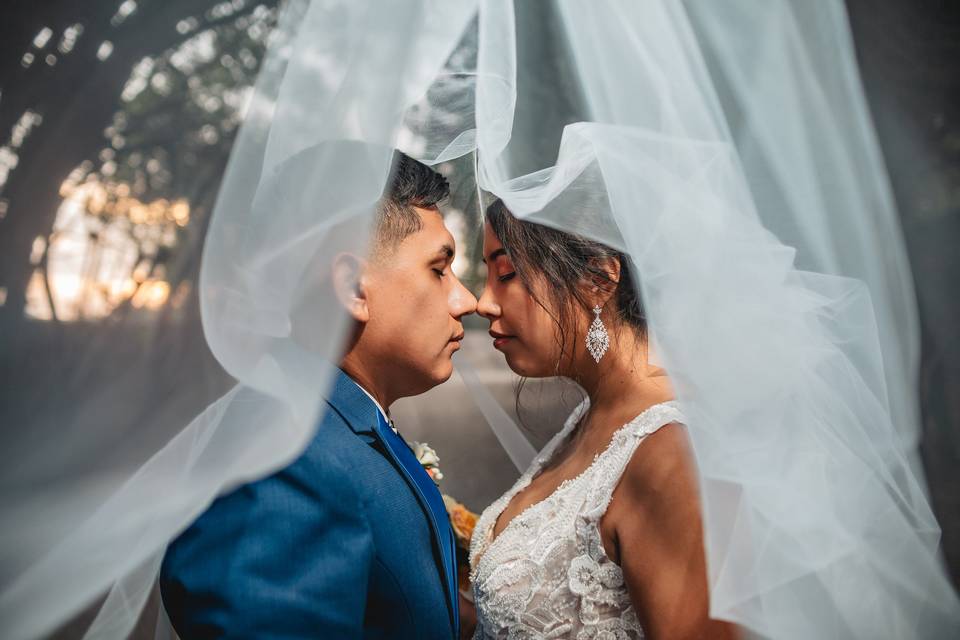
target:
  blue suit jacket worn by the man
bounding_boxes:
[160,369,459,640]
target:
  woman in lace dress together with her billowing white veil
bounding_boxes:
[0,0,960,640]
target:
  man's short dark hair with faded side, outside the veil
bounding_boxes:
[372,151,450,253]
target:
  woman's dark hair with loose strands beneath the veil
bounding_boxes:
[486,198,647,364]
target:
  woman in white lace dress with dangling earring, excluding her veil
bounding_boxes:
[470,200,733,638]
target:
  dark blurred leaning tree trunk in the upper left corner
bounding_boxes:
[0,0,277,339]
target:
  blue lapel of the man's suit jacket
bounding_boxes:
[327,369,460,630]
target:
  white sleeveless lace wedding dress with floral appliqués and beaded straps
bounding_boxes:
[470,401,683,640]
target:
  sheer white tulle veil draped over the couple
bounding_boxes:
[0,0,960,639]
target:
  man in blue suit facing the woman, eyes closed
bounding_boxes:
[160,152,477,640]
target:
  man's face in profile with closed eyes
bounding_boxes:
[361,207,477,397]
